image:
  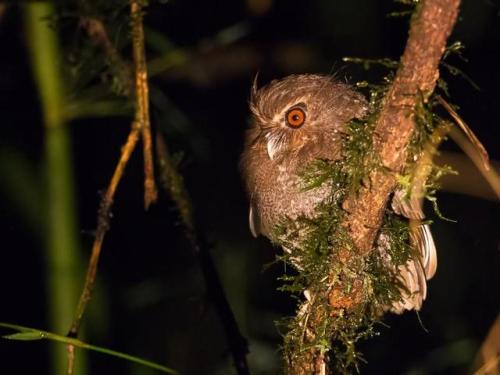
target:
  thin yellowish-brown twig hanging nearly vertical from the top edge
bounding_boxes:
[130,0,158,209]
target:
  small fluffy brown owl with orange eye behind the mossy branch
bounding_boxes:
[240,74,437,313]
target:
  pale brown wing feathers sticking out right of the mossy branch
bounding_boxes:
[391,190,437,314]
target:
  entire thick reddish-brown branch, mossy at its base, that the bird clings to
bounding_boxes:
[285,0,460,374]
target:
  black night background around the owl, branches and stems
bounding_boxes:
[0,0,500,374]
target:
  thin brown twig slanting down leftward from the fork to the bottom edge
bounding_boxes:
[67,122,140,375]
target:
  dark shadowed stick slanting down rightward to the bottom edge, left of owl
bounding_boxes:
[156,133,250,375]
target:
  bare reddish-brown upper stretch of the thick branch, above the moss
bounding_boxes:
[344,0,460,254]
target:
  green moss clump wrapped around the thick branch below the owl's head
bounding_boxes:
[274,116,388,373]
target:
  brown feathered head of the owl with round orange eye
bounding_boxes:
[250,74,367,160]
